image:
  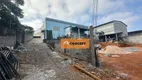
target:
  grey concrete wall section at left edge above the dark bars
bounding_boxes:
[0,36,16,47]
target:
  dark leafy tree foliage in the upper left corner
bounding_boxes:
[0,0,24,29]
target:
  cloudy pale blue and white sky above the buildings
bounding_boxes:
[20,0,142,31]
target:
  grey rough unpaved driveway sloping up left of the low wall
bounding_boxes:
[16,39,92,80]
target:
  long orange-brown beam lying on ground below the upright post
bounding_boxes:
[73,64,101,80]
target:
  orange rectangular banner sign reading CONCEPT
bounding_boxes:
[60,39,89,49]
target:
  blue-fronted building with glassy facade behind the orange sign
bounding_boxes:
[43,18,88,40]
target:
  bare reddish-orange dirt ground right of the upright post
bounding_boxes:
[99,43,142,80]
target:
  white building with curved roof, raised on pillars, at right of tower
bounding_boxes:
[94,20,128,41]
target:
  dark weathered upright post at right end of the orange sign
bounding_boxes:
[90,26,96,66]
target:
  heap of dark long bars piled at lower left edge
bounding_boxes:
[0,47,20,80]
